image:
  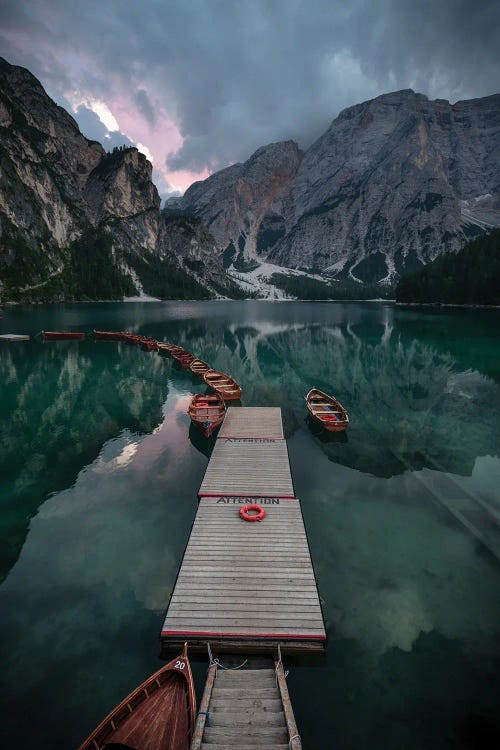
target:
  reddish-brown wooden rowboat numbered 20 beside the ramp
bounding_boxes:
[78,644,196,750]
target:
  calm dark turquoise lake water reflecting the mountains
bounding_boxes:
[0,301,500,750]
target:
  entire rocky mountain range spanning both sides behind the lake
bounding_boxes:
[0,58,500,301]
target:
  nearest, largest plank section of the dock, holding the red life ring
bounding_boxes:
[161,497,326,645]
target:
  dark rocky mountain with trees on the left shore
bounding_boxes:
[0,58,233,301]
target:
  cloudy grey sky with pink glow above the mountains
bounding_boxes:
[0,0,500,195]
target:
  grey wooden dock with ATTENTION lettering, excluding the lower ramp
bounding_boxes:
[161,407,326,654]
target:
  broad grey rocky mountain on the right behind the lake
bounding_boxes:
[177,90,500,282]
